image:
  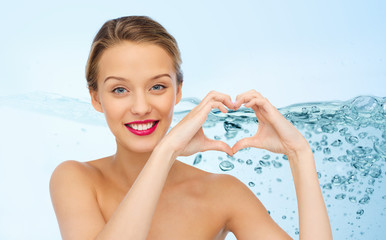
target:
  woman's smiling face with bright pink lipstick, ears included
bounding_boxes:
[90,41,182,152]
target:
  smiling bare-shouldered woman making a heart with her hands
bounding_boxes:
[50,16,332,240]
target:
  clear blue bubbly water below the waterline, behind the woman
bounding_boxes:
[0,92,386,239]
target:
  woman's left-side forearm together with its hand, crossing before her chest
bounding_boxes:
[97,92,233,240]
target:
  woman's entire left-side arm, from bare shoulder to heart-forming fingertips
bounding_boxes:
[50,92,233,240]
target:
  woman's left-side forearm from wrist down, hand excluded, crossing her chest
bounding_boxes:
[96,145,175,240]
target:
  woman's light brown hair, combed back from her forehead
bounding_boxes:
[86,16,183,91]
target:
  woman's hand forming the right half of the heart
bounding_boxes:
[232,90,309,156]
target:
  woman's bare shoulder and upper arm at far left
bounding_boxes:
[49,160,105,239]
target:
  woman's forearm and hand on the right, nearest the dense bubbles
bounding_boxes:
[232,90,332,240]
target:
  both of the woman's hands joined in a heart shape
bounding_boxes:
[163,90,309,156]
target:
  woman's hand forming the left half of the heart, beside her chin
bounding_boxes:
[161,91,234,156]
